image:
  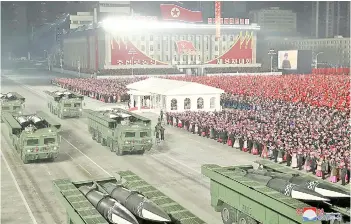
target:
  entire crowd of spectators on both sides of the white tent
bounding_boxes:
[54,72,350,185]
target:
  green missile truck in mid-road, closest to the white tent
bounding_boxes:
[84,108,152,156]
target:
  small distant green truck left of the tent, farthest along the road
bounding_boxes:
[44,91,84,119]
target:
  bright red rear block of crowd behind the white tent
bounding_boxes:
[169,75,350,110]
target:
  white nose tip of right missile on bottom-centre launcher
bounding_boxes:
[141,202,172,222]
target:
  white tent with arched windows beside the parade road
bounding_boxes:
[127,78,224,111]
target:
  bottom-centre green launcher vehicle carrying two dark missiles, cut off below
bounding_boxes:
[53,171,206,224]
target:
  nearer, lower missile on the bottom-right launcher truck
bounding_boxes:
[245,173,329,201]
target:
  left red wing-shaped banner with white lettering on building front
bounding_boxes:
[111,39,167,65]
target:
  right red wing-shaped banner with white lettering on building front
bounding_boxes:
[206,33,252,64]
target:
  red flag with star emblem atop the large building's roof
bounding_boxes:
[160,4,202,22]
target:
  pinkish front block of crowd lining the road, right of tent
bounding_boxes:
[166,103,350,184]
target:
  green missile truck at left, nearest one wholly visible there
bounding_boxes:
[3,111,61,164]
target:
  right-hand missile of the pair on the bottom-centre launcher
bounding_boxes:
[102,183,172,223]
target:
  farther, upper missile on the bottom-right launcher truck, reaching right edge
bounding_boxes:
[248,170,350,199]
